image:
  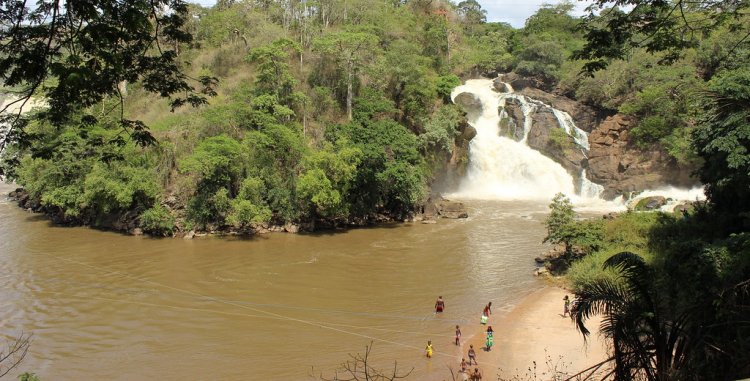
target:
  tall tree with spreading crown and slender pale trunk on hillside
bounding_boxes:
[313,31,378,120]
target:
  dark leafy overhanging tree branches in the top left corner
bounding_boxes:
[0,0,216,162]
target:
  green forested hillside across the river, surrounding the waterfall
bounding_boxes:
[3,0,747,235]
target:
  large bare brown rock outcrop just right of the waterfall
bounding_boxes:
[588,114,697,198]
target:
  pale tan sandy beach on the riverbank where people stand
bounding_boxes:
[456,287,607,380]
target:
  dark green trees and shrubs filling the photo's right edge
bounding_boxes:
[546,1,750,370]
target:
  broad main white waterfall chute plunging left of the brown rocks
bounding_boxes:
[451,79,594,201]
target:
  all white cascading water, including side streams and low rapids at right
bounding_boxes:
[451,79,705,211]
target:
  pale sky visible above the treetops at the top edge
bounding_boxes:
[191,0,591,28]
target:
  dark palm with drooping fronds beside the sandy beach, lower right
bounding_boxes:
[575,252,691,381]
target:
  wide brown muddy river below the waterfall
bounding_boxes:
[0,185,547,381]
